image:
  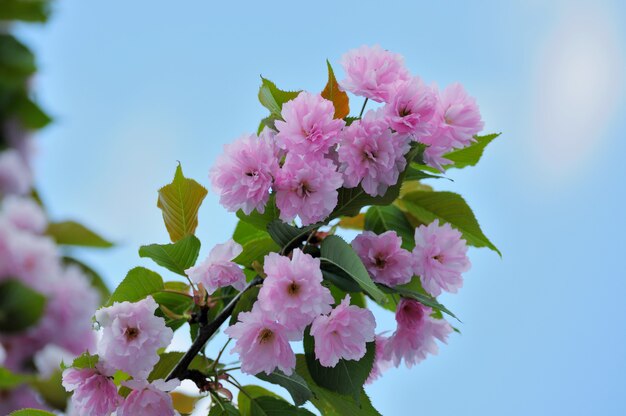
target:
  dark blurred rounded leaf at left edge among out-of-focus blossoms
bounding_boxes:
[0,279,46,333]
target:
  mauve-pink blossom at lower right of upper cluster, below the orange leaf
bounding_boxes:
[338,111,410,196]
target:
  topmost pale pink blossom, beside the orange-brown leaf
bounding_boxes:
[341,45,411,103]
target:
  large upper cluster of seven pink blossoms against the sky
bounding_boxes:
[210,46,483,225]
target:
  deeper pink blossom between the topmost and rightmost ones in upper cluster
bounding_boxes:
[384,77,437,137]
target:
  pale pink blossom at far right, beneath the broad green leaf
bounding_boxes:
[413,220,471,296]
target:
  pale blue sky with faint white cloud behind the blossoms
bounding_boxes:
[15,0,626,415]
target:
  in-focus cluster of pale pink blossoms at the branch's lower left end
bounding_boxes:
[63,296,180,416]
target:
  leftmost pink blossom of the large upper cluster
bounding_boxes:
[209,135,278,214]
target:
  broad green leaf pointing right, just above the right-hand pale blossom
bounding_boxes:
[399,191,502,256]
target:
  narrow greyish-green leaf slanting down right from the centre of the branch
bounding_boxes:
[321,235,386,303]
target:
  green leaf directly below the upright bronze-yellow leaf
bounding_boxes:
[139,235,200,276]
